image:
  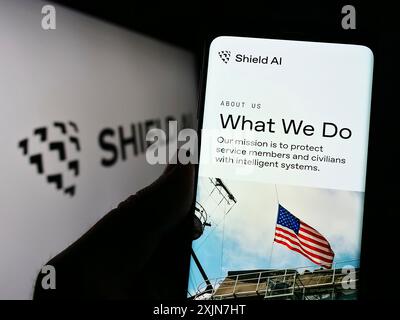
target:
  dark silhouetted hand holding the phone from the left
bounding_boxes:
[34,164,194,299]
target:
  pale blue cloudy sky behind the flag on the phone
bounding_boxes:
[189,177,364,293]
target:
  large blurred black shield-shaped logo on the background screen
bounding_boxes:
[18,121,81,197]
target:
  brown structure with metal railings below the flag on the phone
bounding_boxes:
[194,260,359,300]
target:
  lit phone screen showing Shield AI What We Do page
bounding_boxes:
[188,36,373,300]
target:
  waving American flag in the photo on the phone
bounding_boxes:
[274,205,335,269]
